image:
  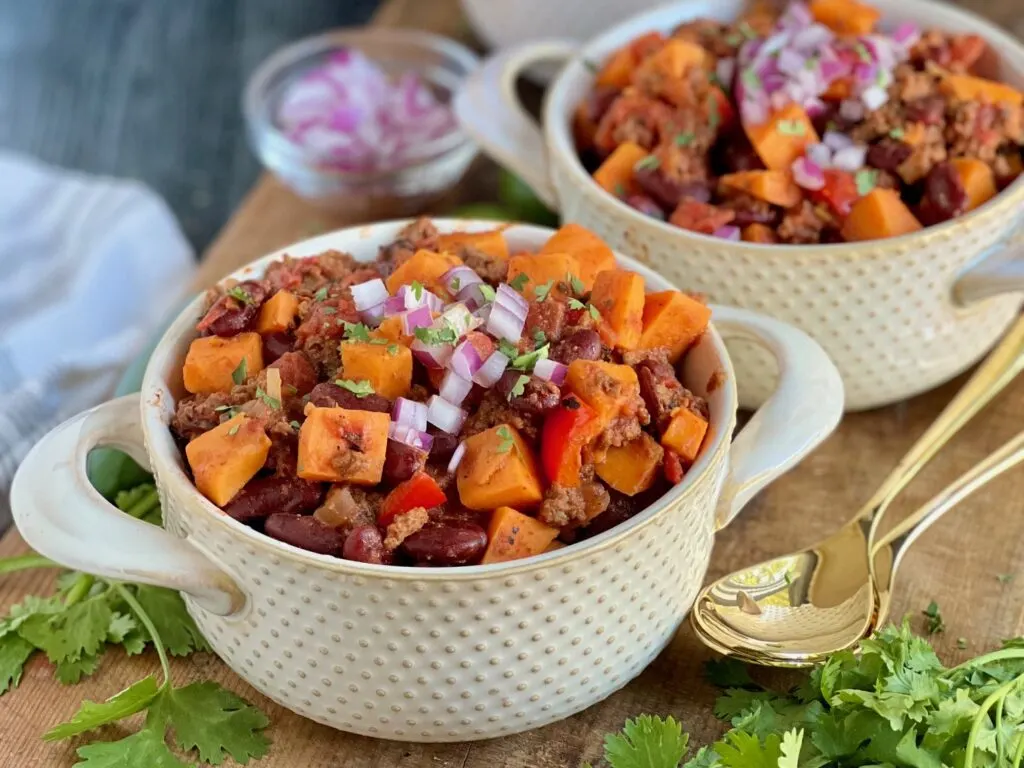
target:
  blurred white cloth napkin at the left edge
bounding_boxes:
[0,153,195,530]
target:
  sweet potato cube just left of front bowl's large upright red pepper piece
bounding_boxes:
[456,424,544,510]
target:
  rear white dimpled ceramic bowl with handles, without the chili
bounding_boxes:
[456,0,1024,410]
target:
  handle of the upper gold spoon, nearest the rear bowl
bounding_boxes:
[861,315,1024,541]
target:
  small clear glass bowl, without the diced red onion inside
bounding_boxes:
[243,29,479,221]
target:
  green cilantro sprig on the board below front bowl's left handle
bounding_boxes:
[0,482,269,768]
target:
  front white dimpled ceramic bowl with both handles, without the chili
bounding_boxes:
[11,220,843,741]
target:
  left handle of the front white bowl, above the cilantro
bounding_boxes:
[10,393,245,615]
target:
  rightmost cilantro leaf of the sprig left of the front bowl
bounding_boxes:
[145,682,270,765]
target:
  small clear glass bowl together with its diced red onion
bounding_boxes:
[243,29,478,219]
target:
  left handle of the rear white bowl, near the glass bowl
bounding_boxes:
[455,40,579,211]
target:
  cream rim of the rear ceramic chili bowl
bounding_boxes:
[542,0,1024,257]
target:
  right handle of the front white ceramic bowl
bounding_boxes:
[712,306,843,528]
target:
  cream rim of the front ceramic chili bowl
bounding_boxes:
[140,218,738,582]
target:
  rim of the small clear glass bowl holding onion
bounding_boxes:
[242,27,480,182]
